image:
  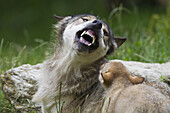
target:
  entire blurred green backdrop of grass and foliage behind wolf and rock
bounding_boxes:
[0,0,170,70]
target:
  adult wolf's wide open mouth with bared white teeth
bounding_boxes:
[77,29,96,46]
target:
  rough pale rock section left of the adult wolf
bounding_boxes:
[1,64,42,113]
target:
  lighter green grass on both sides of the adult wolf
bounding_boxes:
[0,7,170,113]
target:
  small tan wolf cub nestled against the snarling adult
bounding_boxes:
[99,61,170,113]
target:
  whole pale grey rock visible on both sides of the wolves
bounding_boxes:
[1,60,170,113]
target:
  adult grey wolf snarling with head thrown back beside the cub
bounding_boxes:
[32,14,126,113]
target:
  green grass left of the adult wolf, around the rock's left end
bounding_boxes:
[0,39,47,113]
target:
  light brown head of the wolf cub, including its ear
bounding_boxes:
[99,61,144,88]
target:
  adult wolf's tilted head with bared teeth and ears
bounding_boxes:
[55,14,126,65]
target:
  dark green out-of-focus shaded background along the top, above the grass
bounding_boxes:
[0,0,167,45]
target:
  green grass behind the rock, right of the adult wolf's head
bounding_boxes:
[108,6,170,63]
